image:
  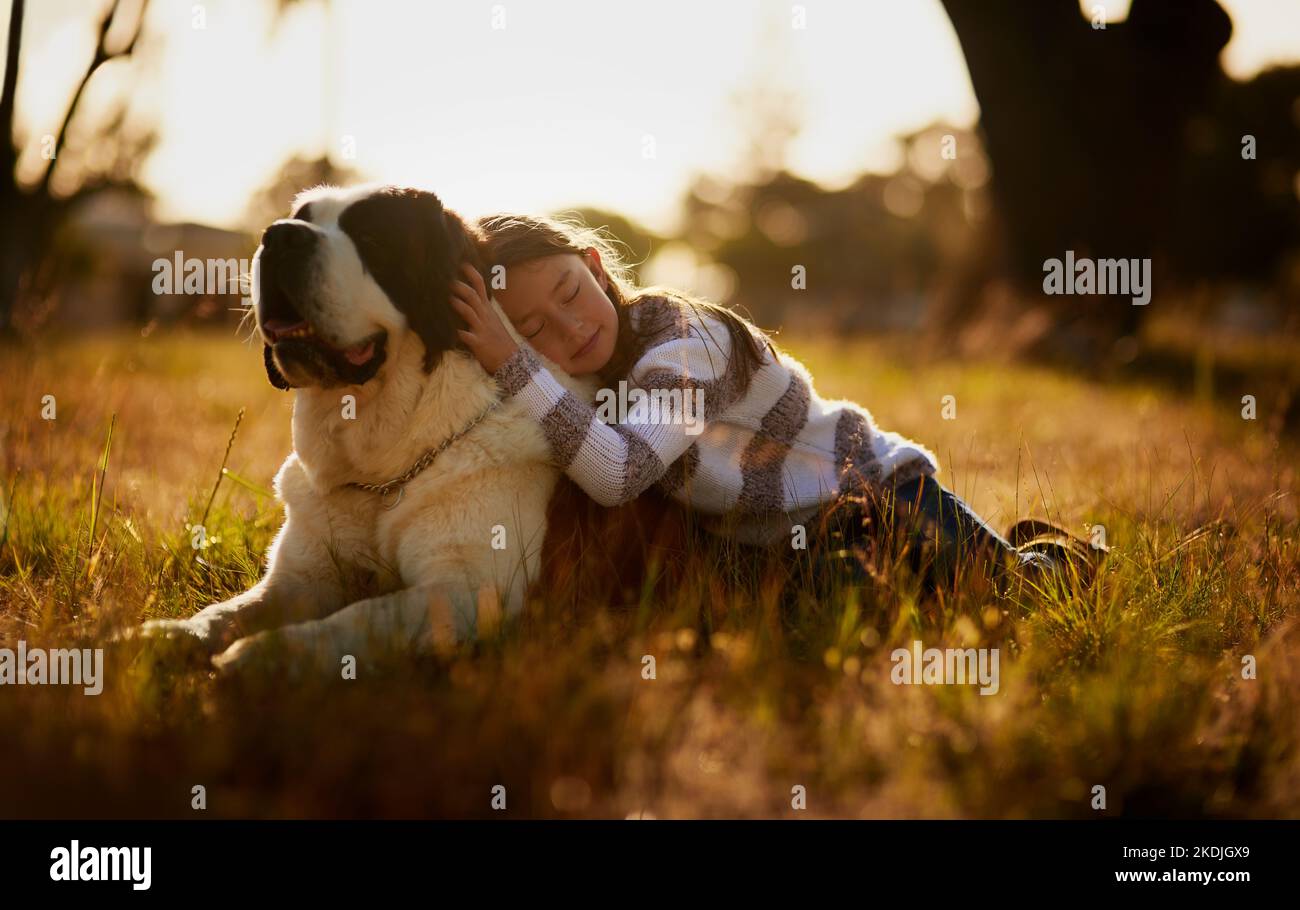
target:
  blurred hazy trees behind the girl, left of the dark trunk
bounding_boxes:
[681,124,987,332]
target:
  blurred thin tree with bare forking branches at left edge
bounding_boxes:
[0,0,156,335]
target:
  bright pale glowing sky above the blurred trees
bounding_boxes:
[10,0,1300,229]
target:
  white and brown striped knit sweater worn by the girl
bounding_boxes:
[494,296,939,543]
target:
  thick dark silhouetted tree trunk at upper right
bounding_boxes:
[943,0,1232,360]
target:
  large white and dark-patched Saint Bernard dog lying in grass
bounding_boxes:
[131,186,595,673]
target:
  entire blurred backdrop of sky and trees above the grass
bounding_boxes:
[0,0,1300,367]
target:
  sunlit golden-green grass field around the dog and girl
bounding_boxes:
[0,325,1300,818]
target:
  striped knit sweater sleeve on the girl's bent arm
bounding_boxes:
[493,324,741,506]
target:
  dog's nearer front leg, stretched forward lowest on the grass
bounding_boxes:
[212,585,514,675]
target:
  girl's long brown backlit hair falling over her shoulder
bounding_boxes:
[478,215,776,387]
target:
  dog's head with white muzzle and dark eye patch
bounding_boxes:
[252,186,484,389]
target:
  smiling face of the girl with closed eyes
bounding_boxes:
[493,251,619,376]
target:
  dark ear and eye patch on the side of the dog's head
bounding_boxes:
[339,187,481,373]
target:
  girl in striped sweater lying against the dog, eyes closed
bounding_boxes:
[452,215,1092,592]
